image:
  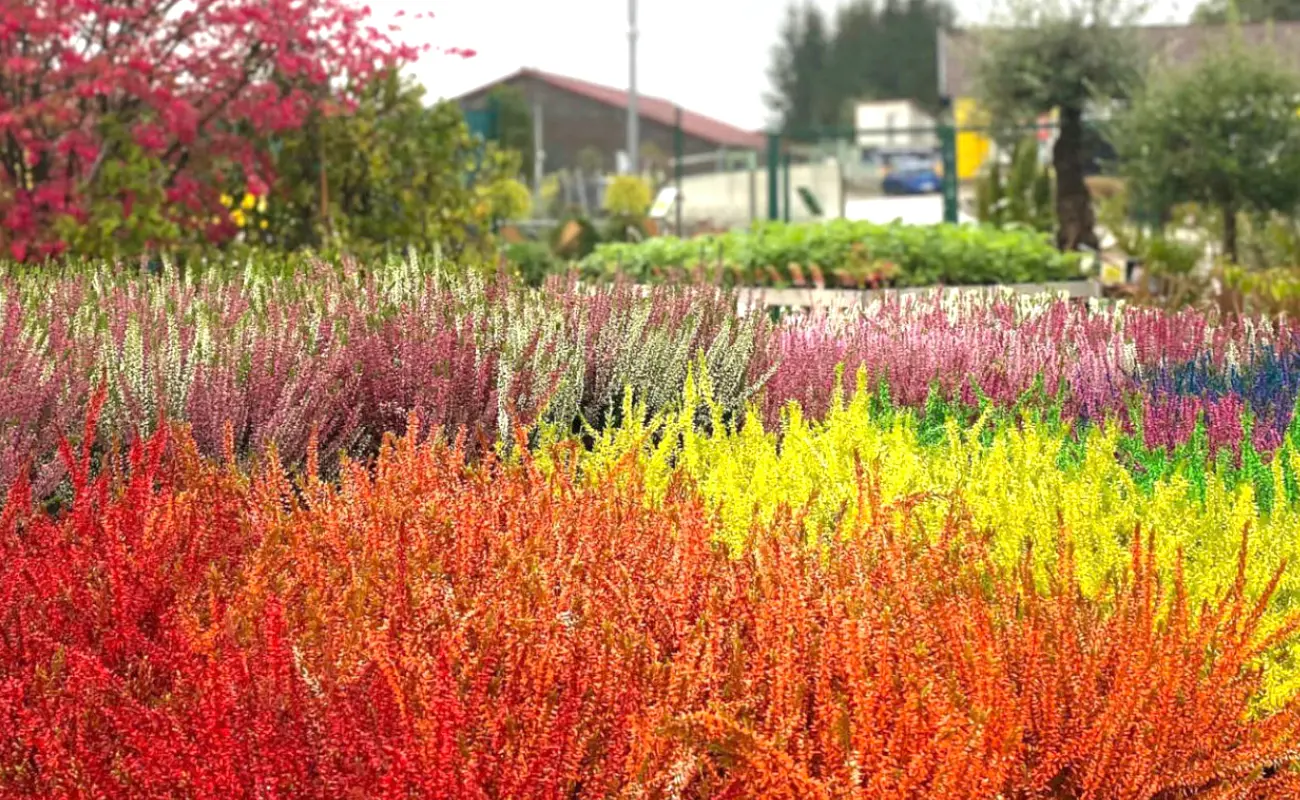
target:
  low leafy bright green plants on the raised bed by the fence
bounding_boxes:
[581,220,1080,287]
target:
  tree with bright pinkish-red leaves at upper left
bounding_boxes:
[0,0,447,260]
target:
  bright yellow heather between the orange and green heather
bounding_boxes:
[540,368,1300,705]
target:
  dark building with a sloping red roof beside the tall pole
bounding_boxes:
[458,69,766,172]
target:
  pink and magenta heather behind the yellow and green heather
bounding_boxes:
[762,294,1300,440]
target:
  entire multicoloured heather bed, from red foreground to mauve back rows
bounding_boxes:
[0,258,1300,800]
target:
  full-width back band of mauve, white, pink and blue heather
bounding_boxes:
[0,267,1300,507]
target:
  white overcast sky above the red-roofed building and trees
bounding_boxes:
[368,0,1192,129]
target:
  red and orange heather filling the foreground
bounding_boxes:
[0,424,1300,800]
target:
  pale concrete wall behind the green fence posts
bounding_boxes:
[670,160,845,226]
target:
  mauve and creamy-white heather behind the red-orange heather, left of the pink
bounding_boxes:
[0,258,767,496]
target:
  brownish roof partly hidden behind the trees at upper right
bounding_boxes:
[939,22,1300,98]
